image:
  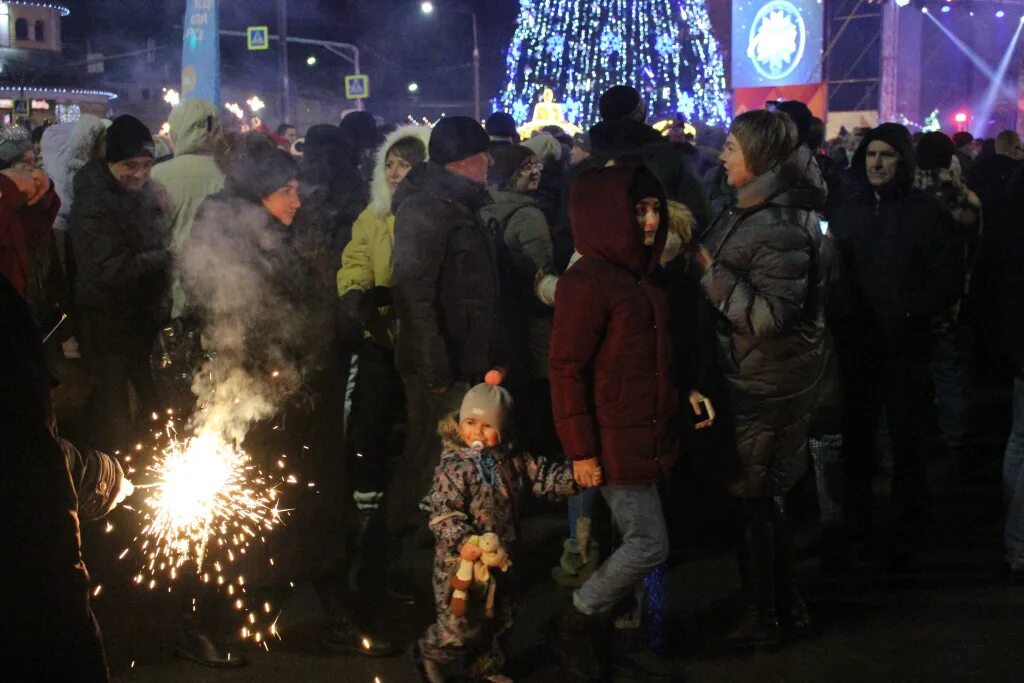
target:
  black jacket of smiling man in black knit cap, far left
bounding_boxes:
[71,160,170,312]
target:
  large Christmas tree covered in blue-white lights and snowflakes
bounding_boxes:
[496,0,728,125]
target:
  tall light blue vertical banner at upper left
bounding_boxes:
[181,0,220,106]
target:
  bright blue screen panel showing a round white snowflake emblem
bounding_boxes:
[731,0,824,88]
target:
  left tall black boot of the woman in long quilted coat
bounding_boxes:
[726,521,782,649]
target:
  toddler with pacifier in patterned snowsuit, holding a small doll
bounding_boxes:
[414,371,599,682]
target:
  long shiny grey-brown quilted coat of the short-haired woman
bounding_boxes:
[700,147,827,498]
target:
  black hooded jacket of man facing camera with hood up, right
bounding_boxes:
[829,124,964,355]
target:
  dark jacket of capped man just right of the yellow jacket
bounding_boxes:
[391,156,498,387]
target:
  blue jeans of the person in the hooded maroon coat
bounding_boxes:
[572,483,669,614]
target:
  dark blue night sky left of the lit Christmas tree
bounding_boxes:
[57,0,518,115]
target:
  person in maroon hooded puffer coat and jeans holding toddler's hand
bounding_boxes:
[550,166,712,680]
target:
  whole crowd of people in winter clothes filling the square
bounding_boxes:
[0,86,1024,683]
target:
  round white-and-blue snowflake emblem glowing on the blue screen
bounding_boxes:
[746,0,807,81]
